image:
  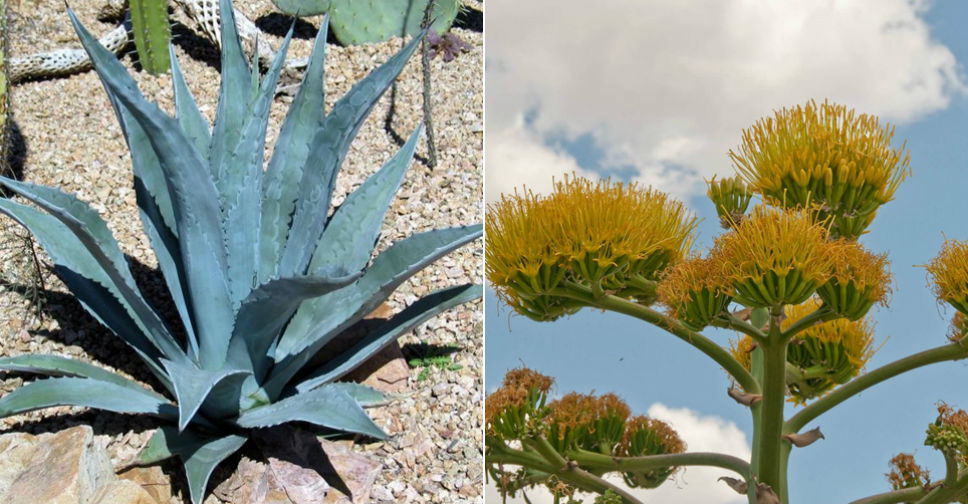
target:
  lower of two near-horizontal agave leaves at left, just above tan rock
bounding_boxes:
[0,377,177,420]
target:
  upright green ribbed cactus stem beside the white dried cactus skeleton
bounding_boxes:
[129,0,171,75]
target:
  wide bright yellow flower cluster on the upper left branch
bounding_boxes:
[485,177,696,319]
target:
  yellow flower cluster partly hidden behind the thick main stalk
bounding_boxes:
[730,299,874,404]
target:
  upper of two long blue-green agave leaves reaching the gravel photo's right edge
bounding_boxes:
[275,224,483,362]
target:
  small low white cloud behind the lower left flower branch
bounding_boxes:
[484,403,751,504]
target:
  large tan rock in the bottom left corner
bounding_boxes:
[0,425,164,504]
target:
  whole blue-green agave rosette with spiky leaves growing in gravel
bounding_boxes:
[0,0,482,503]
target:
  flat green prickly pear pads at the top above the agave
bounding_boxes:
[329,0,460,45]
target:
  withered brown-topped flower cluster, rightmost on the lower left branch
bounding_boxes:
[618,415,686,488]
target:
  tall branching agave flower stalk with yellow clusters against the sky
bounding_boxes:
[485,101,968,504]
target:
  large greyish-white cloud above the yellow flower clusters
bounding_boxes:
[486,0,966,200]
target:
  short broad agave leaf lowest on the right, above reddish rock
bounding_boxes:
[236,388,386,439]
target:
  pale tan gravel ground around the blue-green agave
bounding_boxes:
[0,0,483,503]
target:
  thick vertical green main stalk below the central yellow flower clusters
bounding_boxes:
[753,332,787,495]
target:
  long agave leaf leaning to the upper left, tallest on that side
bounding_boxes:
[68,11,233,368]
